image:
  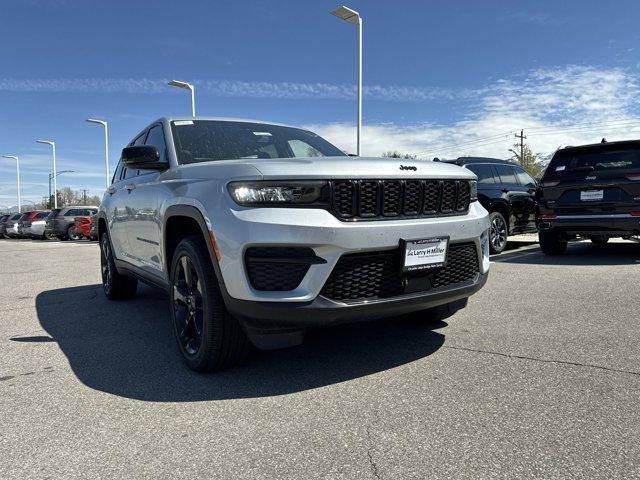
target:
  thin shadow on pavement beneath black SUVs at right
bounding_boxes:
[491,242,640,266]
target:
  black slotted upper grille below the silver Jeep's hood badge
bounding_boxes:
[331,180,471,220]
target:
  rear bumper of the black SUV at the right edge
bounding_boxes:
[539,213,640,236]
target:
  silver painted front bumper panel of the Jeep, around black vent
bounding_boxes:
[211,200,489,304]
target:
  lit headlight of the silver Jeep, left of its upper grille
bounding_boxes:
[228,181,327,206]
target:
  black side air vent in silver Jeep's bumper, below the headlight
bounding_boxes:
[245,247,321,292]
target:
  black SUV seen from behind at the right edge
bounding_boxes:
[538,140,640,255]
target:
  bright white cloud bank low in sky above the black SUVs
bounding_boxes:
[308,65,640,158]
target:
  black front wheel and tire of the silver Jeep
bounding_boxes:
[169,236,250,372]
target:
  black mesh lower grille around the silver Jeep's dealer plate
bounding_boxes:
[320,243,479,302]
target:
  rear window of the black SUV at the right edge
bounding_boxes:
[546,147,640,176]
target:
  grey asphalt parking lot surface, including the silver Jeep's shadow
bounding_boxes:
[0,240,640,479]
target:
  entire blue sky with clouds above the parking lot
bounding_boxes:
[0,0,640,205]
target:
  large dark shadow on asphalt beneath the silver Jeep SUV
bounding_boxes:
[36,285,446,402]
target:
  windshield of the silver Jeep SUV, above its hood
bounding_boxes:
[171,120,345,164]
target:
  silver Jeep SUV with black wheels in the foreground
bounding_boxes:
[98,118,490,371]
